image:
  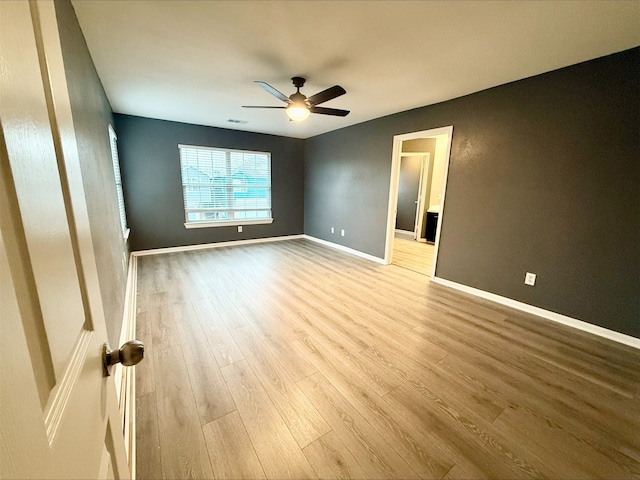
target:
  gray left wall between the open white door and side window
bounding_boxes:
[55,1,129,345]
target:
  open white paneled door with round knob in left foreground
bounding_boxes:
[0,0,129,479]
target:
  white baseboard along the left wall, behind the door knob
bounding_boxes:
[116,254,138,480]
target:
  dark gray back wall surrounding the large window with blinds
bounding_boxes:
[115,114,304,250]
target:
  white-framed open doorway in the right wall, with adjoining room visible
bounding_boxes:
[385,126,453,277]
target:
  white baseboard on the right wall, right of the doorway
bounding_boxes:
[431,277,640,349]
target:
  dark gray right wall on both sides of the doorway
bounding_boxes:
[305,48,640,337]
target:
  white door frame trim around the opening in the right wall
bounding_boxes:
[384,125,453,278]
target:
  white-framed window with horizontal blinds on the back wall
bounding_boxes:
[178,145,273,228]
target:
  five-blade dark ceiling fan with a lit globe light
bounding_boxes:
[243,77,349,122]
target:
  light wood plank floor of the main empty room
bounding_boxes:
[136,240,640,479]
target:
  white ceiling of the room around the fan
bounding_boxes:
[73,0,640,138]
